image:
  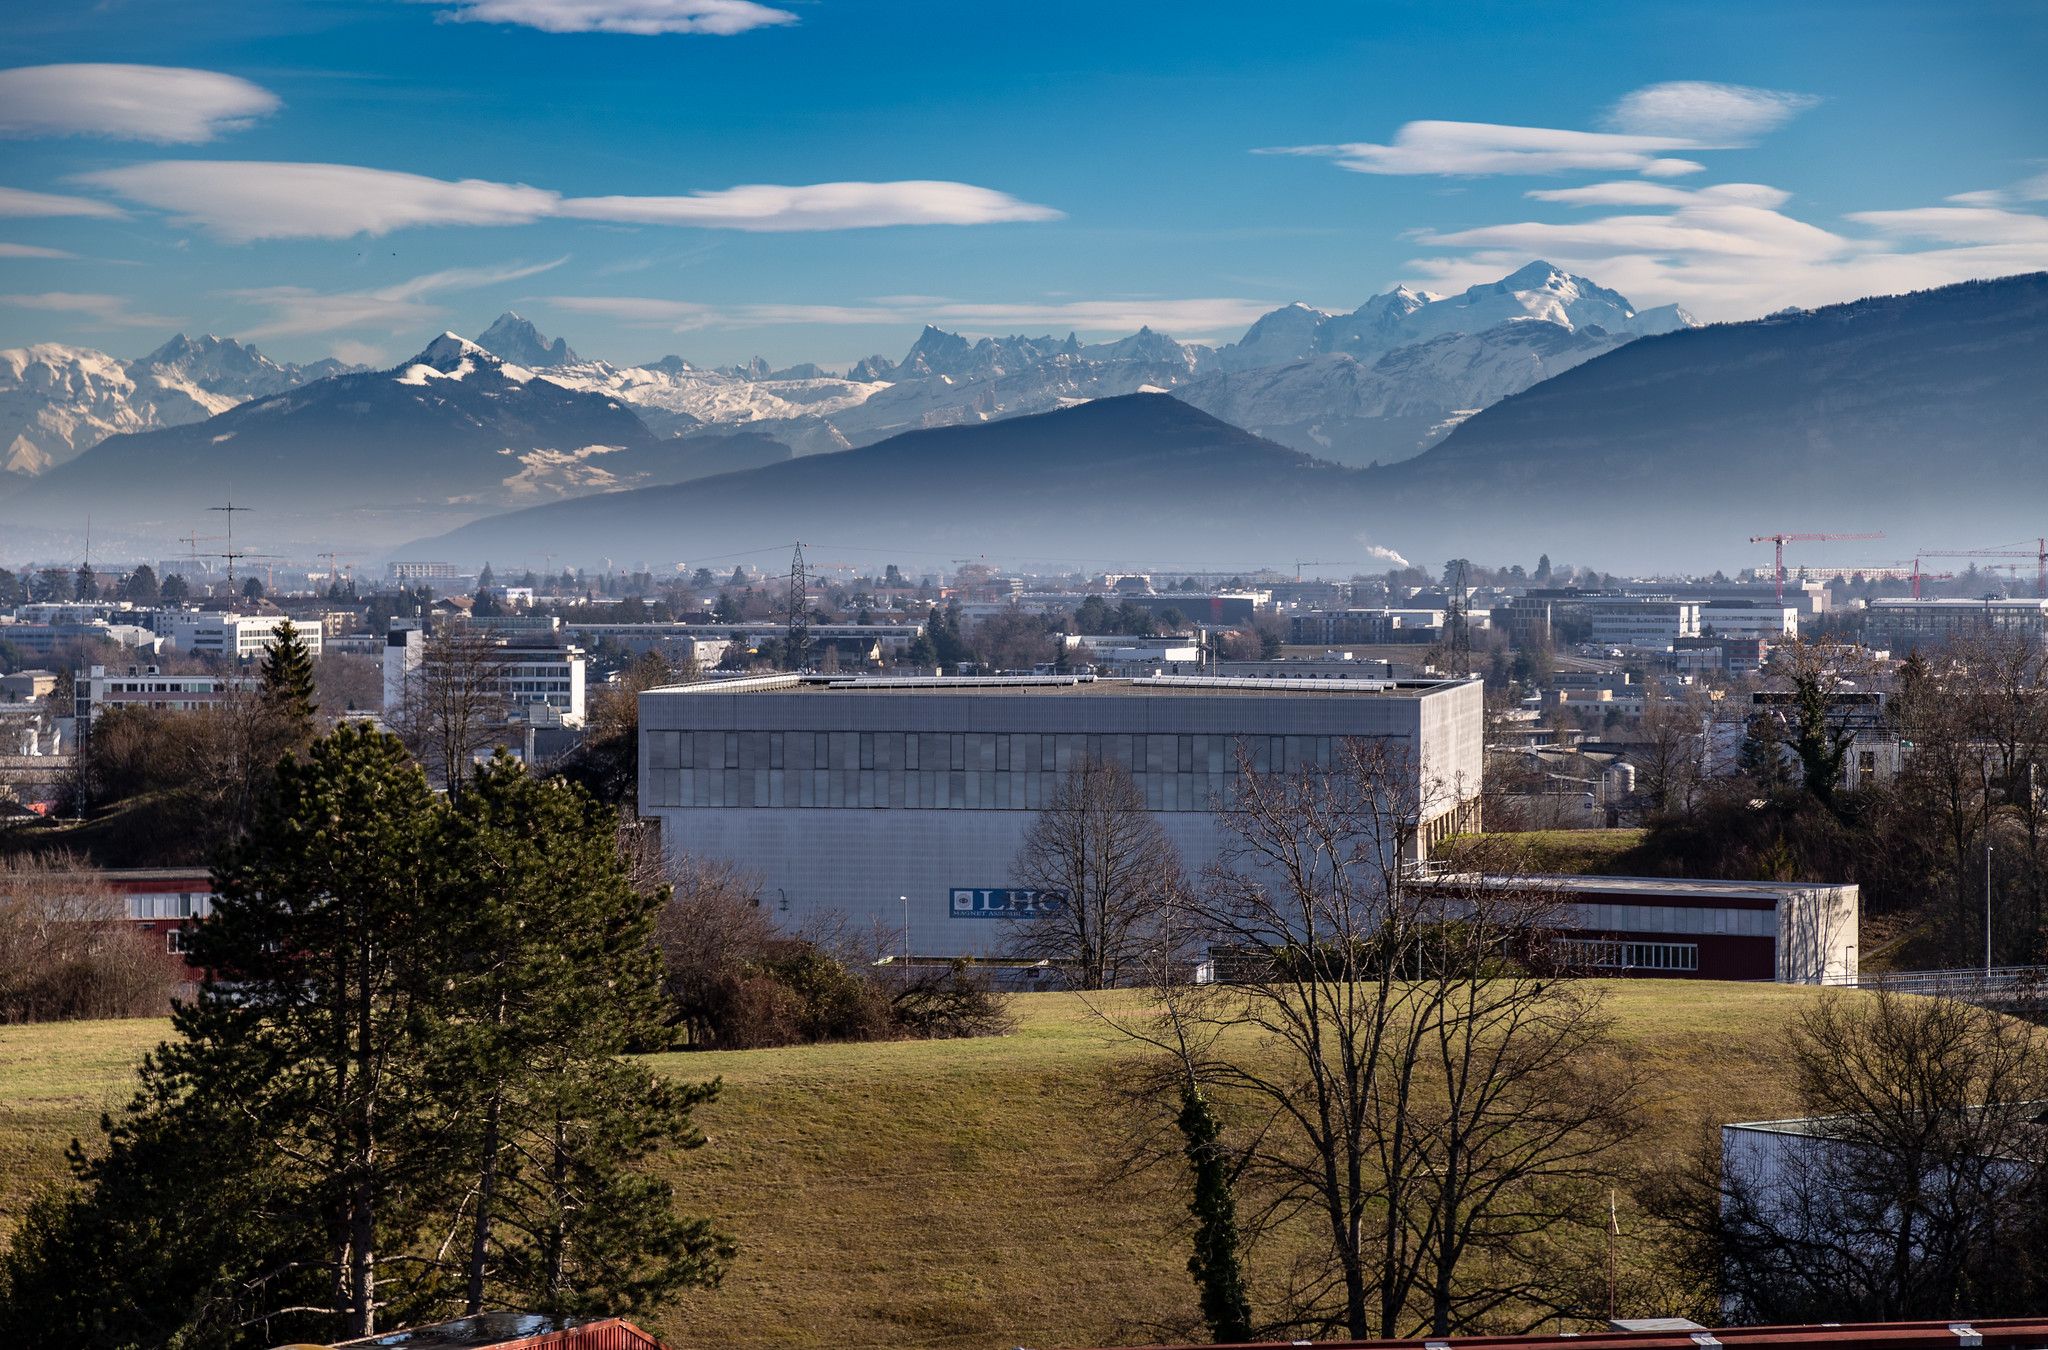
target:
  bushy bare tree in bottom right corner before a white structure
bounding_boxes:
[1645,992,2048,1321]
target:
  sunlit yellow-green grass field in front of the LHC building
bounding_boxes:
[0,981,1817,1350]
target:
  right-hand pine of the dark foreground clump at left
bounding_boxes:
[449,752,733,1313]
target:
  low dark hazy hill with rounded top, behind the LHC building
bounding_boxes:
[408,393,1362,563]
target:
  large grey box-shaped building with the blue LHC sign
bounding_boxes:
[639,676,1485,957]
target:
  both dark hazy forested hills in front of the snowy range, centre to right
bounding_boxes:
[408,272,2048,569]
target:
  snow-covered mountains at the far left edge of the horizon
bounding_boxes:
[0,334,362,477]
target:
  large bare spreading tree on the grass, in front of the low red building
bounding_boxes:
[1153,740,1636,1338]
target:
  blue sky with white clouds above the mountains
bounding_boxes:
[0,0,2048,365]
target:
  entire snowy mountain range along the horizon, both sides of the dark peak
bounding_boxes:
[0,262,1692,510]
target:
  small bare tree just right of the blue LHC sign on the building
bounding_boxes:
[1016,754,1184,989]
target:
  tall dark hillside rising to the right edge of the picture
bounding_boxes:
[1380,272,2048,563]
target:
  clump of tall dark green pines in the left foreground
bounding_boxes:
[0,727,733,1350]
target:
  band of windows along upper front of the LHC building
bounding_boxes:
[643,731,1392,811]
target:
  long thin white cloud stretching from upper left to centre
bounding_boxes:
[80,160,1061,244]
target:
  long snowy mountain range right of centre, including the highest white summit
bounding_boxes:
[512,262,1692,465]
